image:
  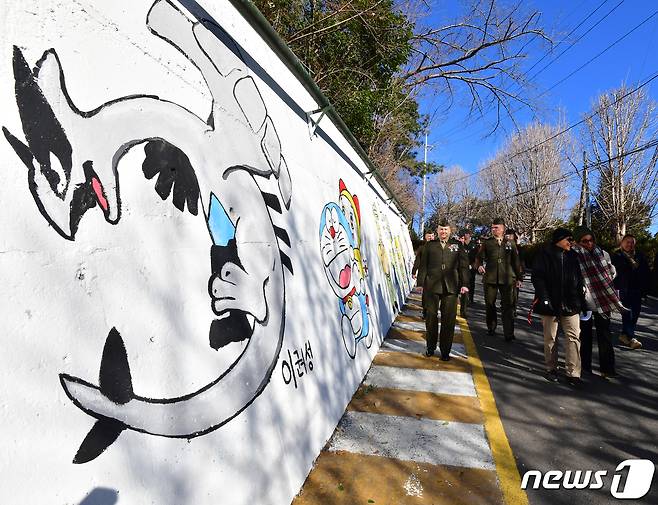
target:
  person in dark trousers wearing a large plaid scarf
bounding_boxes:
[572,227,626,378]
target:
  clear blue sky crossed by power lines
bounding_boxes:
[420,0,658,231]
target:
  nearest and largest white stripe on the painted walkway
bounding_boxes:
[329,411,495,470]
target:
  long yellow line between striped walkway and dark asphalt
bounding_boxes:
[457,317,528,505]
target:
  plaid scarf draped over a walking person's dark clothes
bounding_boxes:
[572,245,626,312]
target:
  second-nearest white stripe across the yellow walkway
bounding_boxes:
[363,365,476,396]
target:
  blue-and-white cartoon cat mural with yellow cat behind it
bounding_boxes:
[320,180,372,358]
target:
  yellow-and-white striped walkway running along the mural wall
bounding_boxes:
[293,295,528,505]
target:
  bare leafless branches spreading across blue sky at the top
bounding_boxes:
[401,0,550,131]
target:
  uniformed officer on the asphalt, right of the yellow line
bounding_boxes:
[475,218,523,342]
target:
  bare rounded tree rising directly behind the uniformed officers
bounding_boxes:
[482,123,573,242]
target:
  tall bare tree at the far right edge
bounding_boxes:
[583,86,658,240]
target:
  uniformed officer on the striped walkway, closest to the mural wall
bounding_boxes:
[418,221,469,361]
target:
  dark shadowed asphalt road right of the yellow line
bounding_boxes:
[468,277,658,505]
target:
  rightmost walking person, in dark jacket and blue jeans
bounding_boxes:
[612,235,650,349]
